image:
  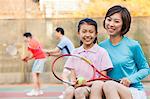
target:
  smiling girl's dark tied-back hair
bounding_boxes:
[78,18,98,45]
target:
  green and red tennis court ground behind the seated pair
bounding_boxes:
[0,83,150,99]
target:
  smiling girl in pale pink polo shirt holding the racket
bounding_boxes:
[64,18,113,99]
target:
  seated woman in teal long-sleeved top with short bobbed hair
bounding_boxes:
[99,5,149,99]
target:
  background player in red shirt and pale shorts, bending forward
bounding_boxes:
[23,32,46,96]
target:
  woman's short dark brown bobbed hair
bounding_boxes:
[103,5,131,36]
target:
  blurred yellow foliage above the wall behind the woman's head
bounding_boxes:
[74,0,150,17]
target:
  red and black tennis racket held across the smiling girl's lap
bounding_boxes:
[52,54,119,85]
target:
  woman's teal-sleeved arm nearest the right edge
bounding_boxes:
[128,42,150,83]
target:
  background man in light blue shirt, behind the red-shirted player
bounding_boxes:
[46,27,74,98]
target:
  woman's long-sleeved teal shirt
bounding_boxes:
[99,37,150,90]
